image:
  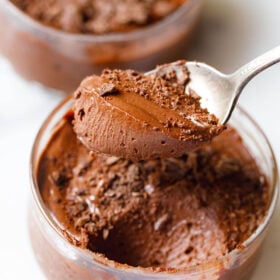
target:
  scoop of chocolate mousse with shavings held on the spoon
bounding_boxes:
[74,61,225,160]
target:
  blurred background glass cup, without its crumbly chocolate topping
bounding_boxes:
[0,0,203,93]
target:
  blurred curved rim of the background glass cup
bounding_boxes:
[0,0,203,43]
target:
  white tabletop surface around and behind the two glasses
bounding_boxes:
[0,0,280,280]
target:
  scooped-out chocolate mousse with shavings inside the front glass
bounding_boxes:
[37,111,268,270]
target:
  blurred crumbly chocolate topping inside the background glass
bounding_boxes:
[11,0,186,34]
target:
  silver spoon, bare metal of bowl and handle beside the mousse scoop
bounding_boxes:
[158,46,280,124]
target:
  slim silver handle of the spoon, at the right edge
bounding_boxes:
[231,46,280,92]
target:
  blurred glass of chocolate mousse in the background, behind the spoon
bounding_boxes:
[0,0,203,93]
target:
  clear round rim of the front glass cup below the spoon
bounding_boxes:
[30,96,279,276]
